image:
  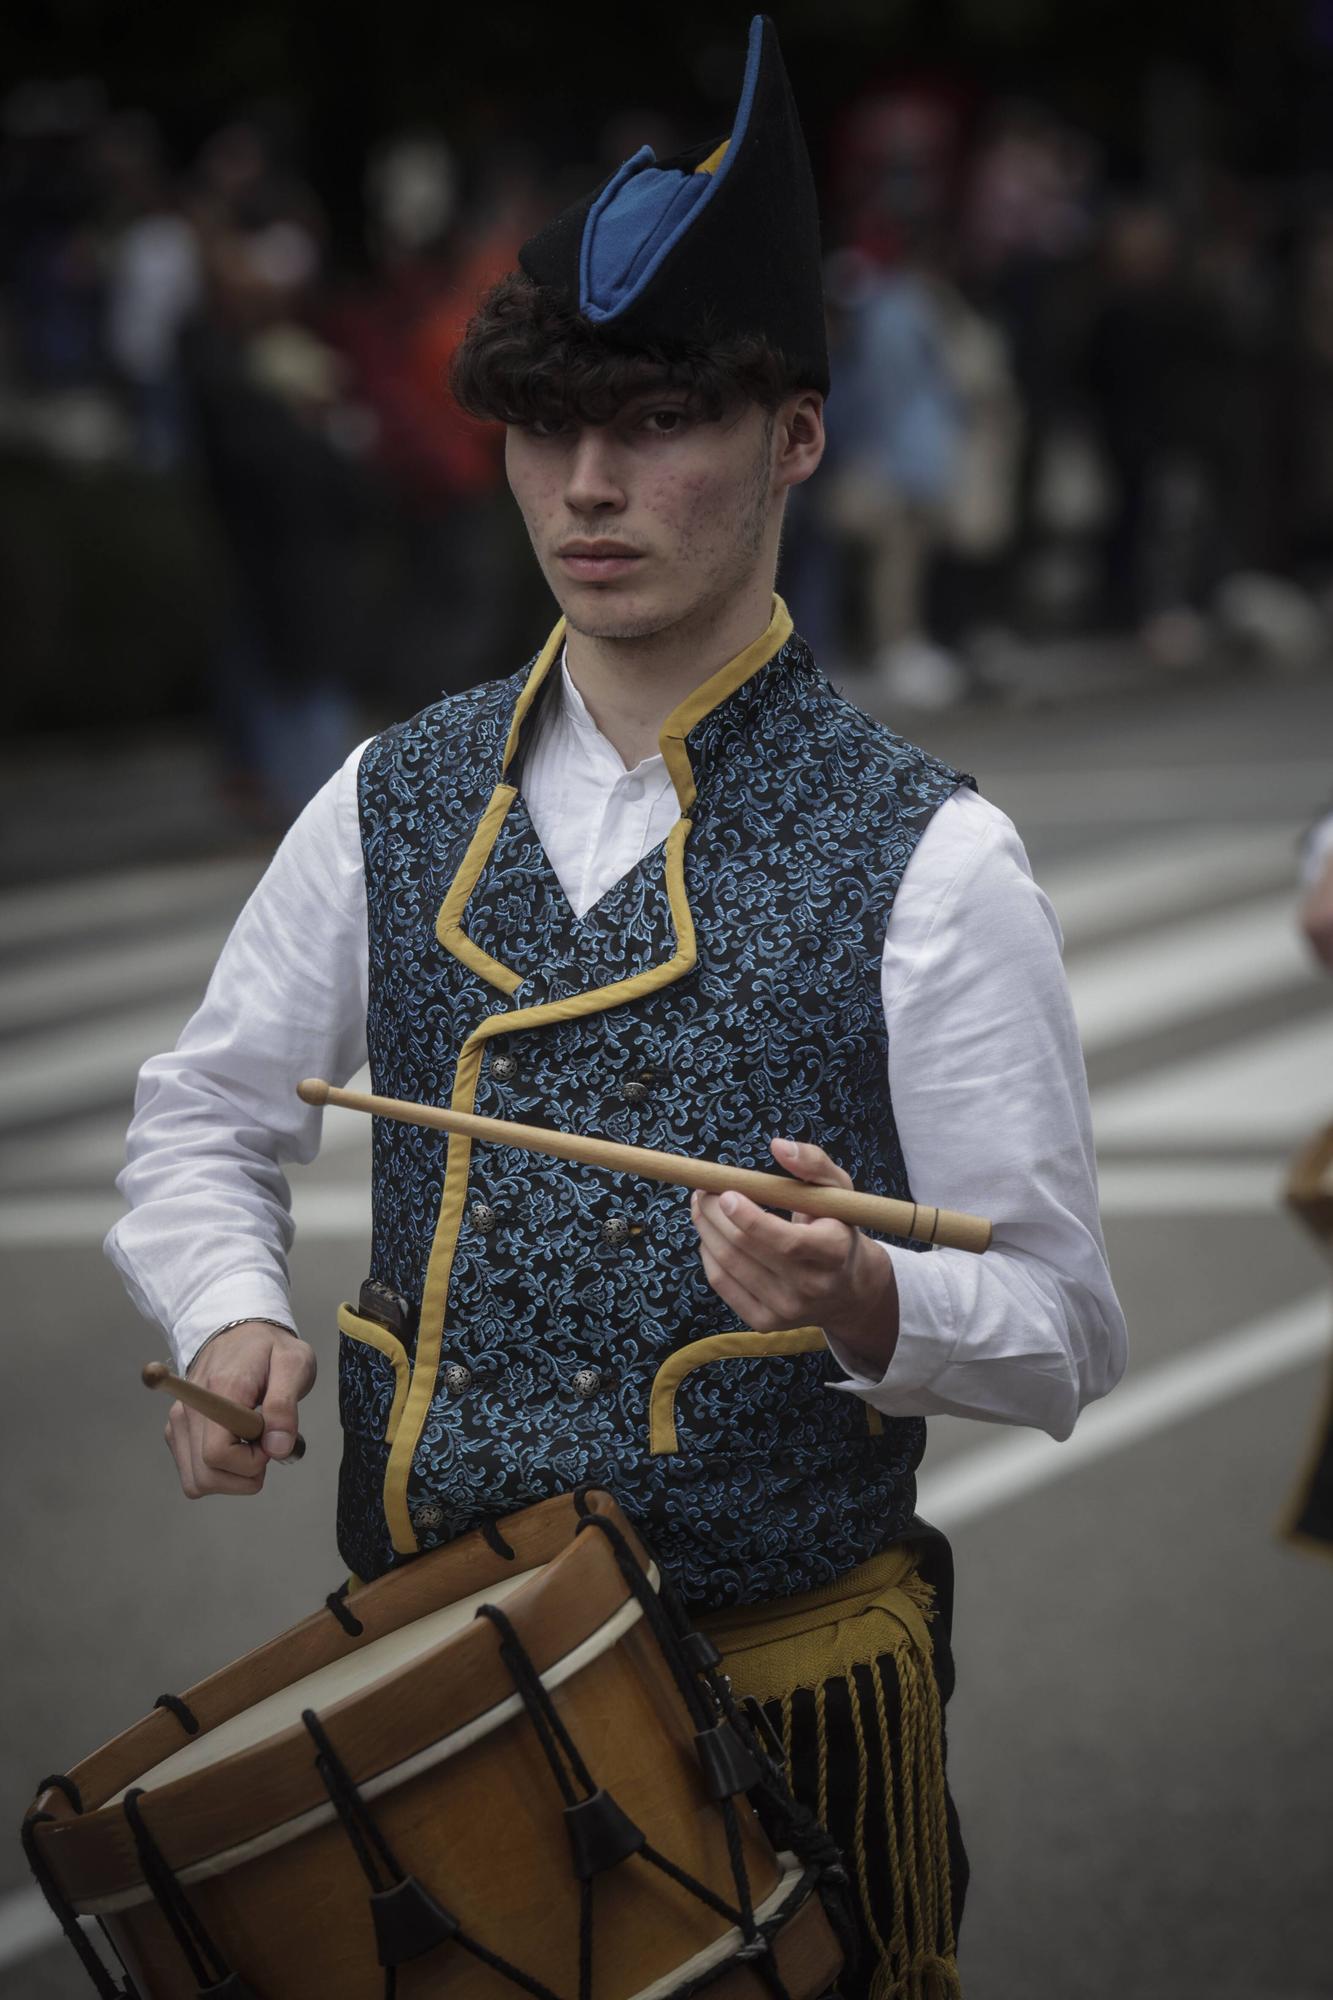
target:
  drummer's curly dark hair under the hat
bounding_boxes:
[448,272,803,426]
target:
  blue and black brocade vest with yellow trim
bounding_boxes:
[338,600,971,1608]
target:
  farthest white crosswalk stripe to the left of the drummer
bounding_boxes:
[0,858,266,948]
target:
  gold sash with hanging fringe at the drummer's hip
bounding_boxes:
[701,1548,963,2000]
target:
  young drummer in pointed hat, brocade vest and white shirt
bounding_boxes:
[110,22,1125,1996]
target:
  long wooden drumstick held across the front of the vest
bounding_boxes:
[296,1076,991,1250]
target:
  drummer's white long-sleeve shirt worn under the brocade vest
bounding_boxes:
[106,666,1125,1438]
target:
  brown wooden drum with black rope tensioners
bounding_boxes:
[24,1492,843,2000]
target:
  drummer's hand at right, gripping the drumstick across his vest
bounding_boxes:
[691,1138,899,1374]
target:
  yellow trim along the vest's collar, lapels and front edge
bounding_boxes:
[384,594,792,1556]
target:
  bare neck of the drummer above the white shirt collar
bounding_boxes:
[564,582,773,770]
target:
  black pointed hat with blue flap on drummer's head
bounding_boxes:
[518,14,829,394]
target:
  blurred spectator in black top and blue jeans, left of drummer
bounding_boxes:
[180,126,374,828]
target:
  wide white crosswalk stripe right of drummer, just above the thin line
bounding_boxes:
[1093,1008,1333,1152]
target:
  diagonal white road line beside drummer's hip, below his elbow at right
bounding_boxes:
[917,1292,1333,1530]
